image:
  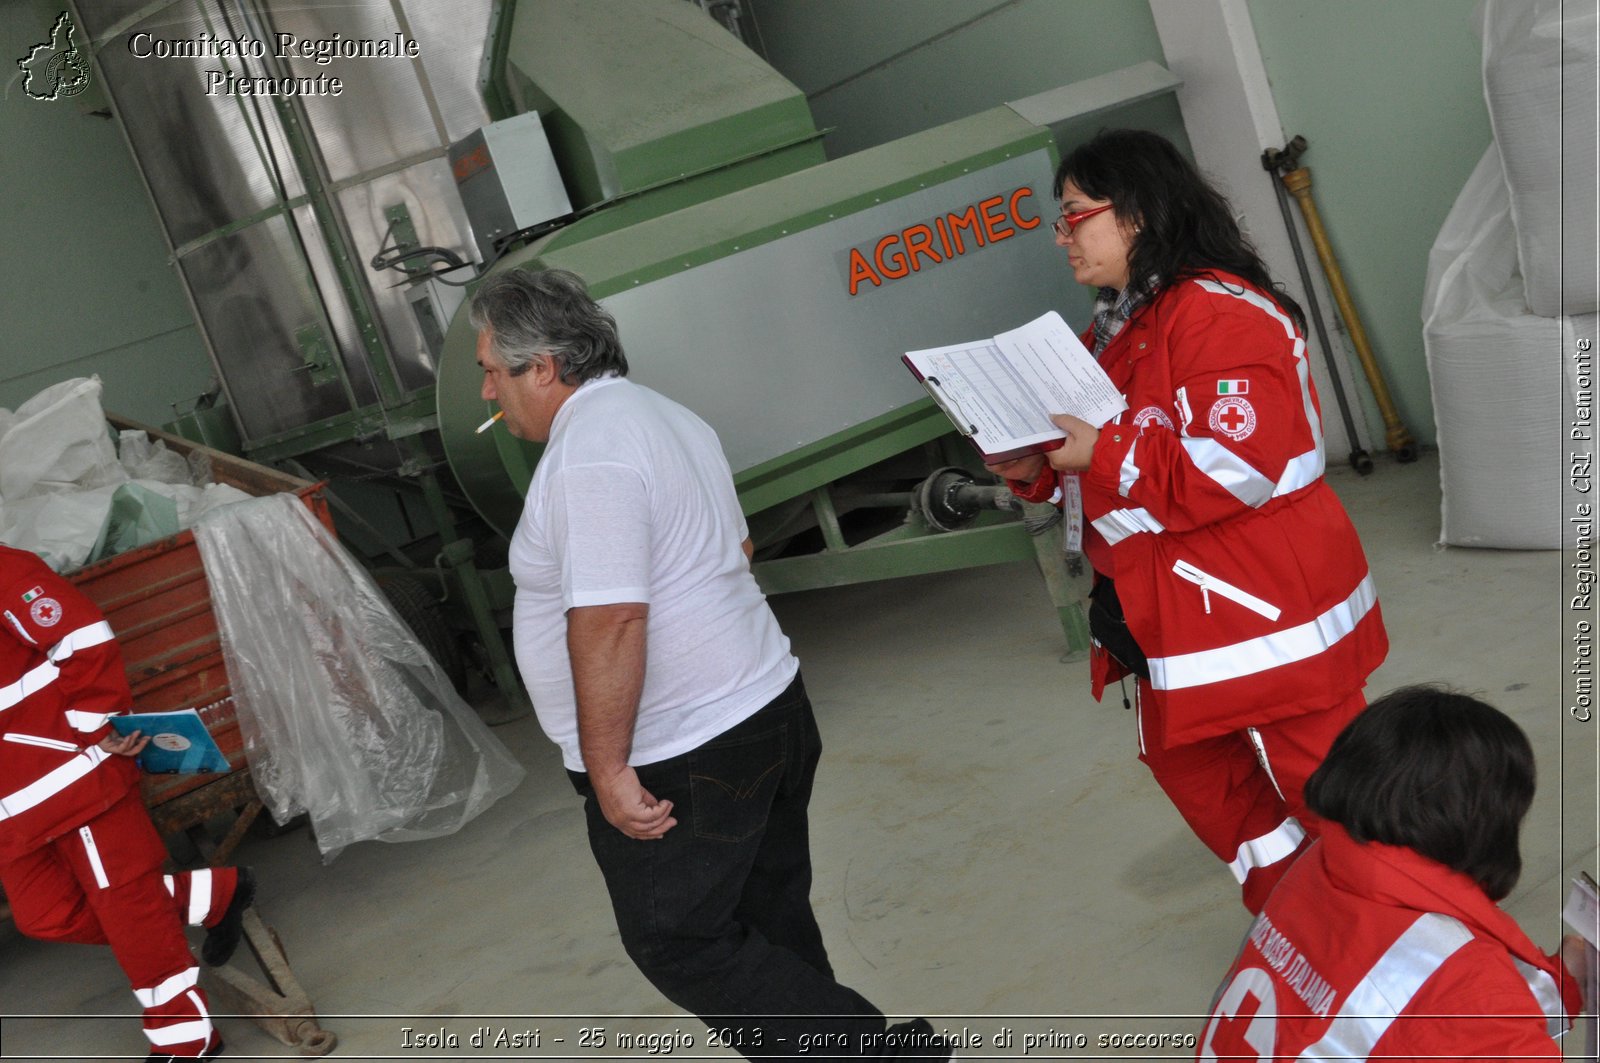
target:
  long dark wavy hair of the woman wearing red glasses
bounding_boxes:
[1054,130,1306,331]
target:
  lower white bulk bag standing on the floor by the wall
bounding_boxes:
[1422,147,1595,549]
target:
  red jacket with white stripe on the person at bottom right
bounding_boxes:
[1197,823,1581,1060]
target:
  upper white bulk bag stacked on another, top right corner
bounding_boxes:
[1482,0,1600,317]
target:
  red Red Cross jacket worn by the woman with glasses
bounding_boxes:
[1013,274,1389,748]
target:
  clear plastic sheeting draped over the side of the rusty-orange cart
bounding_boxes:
[194,495,523,860]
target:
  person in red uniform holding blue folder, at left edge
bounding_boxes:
[0,546,254,1060]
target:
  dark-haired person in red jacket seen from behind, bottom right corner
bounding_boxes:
[1197,687,1581,1061]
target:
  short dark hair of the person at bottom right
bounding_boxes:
[1306,687,1534,901]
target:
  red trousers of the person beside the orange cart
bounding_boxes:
[0,789,238,1057]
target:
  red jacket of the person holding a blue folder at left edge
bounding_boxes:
[0,546,139,863]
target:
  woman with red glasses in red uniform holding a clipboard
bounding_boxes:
[992,130,1387,911]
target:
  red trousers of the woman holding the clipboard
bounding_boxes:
[1139,679,1366,914]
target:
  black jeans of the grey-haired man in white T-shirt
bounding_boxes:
[571,676,938,1060]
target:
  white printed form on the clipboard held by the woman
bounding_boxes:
[904,311,1128,458]
